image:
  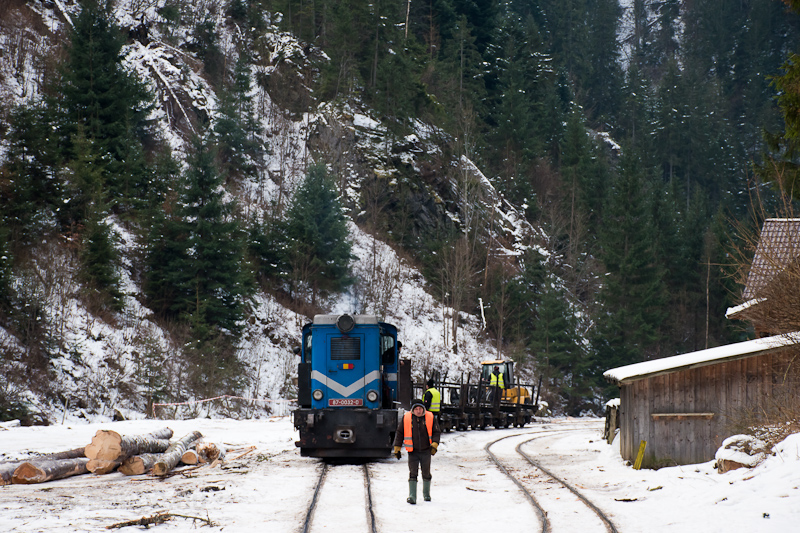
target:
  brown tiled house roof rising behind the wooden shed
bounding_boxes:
[742,218,800,302]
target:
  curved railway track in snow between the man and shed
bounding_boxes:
[484,428,618,533]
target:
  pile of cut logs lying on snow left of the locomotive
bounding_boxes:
[0,428,224,485]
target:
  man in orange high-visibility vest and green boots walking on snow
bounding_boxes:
[394,400,441,504]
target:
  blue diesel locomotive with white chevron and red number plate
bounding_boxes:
[293,314,411,458]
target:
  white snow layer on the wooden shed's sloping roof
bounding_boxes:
[603,332,800,384]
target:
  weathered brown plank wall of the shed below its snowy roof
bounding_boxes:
[619,351,800,468]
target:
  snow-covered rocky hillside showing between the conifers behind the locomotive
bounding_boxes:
[0,0,544,422]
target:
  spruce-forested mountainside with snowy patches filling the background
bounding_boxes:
[0,0,800,422]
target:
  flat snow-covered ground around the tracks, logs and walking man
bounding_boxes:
[0,418,800,533]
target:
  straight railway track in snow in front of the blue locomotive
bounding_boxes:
[301,462,378,533]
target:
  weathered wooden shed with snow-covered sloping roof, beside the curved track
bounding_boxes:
[604,334,800,468]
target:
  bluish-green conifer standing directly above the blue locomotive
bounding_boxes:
[286,164,353,303]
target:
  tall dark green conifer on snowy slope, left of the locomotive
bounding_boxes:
[147,140,252,340]
